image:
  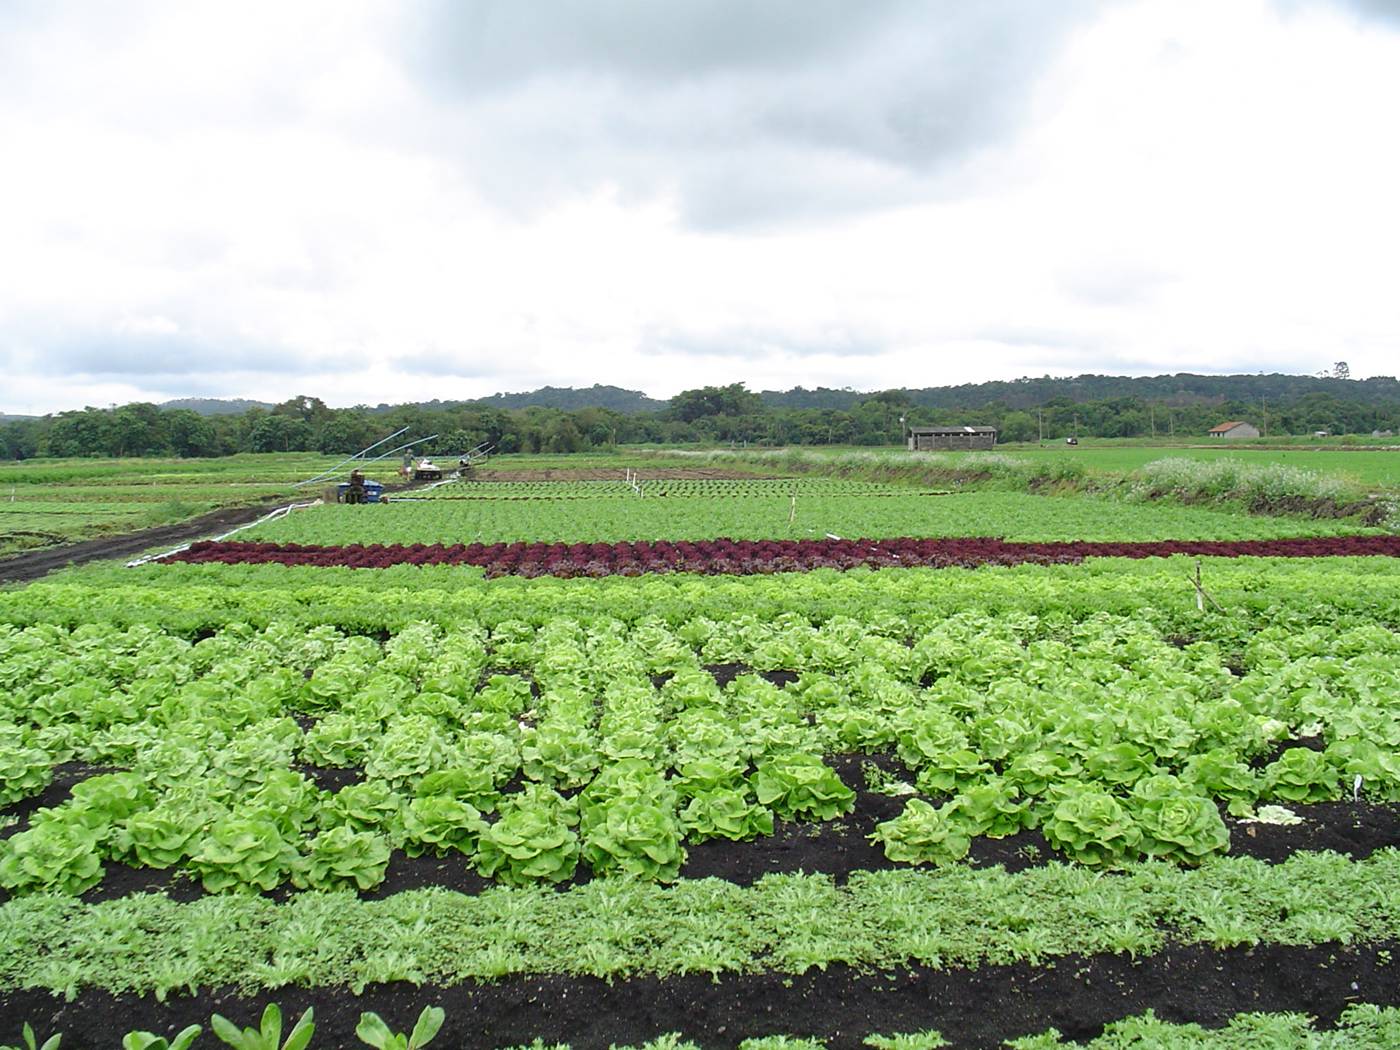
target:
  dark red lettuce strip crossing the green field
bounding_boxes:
[168,536,1400,577]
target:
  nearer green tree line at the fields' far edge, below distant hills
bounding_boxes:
[0,381,1400,459]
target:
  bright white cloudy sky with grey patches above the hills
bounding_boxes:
[0,0,1400,413]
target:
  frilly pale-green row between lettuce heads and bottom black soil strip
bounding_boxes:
[0,850,1400,997]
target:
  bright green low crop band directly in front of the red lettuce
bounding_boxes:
[0,557,1400,641]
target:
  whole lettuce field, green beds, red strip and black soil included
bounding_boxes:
[0,472,1400,1050]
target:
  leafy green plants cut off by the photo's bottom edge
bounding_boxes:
[13,1004,1400,1050]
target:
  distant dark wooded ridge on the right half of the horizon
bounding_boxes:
[759,372,1400,409]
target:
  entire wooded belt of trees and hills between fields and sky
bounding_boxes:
[0,375,1400,459]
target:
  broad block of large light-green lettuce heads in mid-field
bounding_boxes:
[0,596,1400,893]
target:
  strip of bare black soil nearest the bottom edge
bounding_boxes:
[0,939,1400,1050]
